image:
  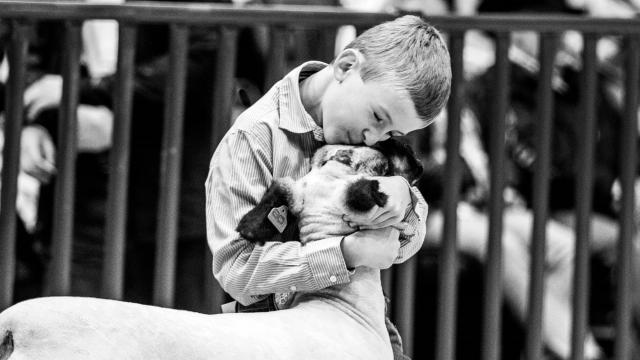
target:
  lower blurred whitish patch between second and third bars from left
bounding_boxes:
[78,105,113,153]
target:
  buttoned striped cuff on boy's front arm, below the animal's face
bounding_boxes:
[302,236,350,289]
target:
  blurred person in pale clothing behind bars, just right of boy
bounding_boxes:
[418,108,602,359]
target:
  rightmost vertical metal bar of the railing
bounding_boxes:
[614,35,640,360]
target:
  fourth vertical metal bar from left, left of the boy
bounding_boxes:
[153,24,189,307]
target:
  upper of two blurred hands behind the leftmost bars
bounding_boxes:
[24,74,62,121]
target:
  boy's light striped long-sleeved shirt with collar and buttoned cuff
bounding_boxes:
[206,62,427,305]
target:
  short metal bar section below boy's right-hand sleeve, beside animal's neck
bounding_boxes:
[393,256,418,357]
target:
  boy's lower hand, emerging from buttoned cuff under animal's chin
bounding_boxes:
[341,227,400,269]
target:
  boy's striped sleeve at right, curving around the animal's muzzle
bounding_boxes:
[394,182,429,264]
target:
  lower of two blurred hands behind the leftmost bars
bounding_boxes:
[20,126,56,184]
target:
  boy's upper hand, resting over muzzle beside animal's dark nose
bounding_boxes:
[343,176,412,230]
